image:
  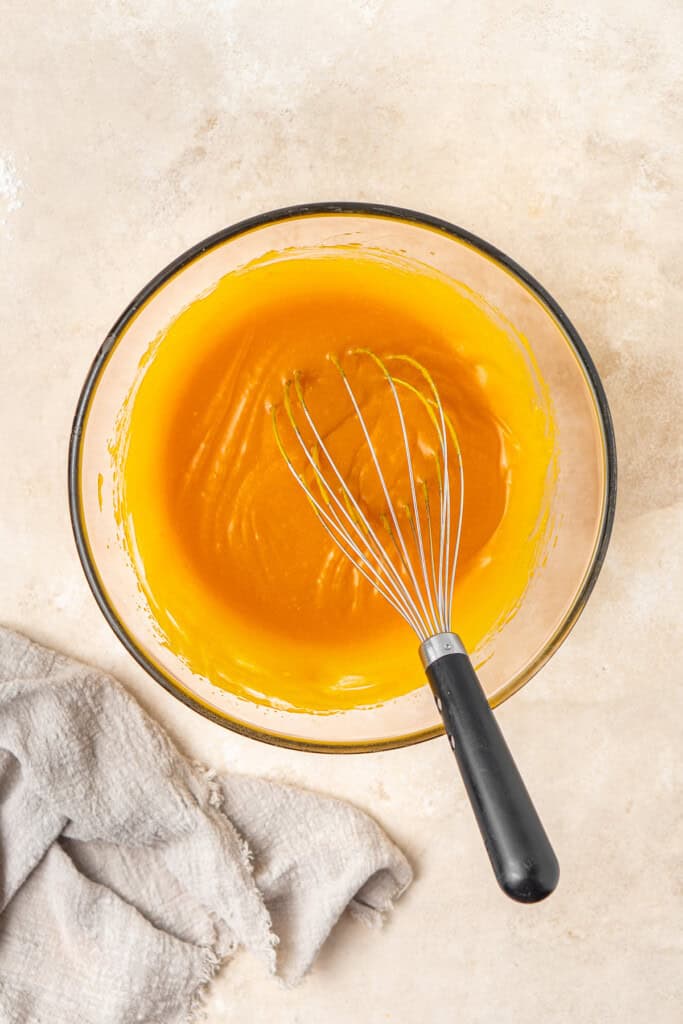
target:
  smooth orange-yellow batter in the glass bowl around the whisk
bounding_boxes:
[113,247,553,713]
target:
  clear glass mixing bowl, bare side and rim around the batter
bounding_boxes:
[69,203,616,753]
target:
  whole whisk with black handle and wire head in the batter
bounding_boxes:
[271,349,559,903]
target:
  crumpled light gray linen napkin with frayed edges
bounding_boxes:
[0,628,412,1024]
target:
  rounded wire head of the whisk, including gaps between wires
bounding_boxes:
[271,348,464,642]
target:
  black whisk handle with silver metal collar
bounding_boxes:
[425,634,559,903]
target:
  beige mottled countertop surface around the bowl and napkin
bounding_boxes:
[0,0,683,1024]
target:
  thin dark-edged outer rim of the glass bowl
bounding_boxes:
[68,202,616,754]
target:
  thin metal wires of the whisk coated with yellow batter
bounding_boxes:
[271,349,464,641]
